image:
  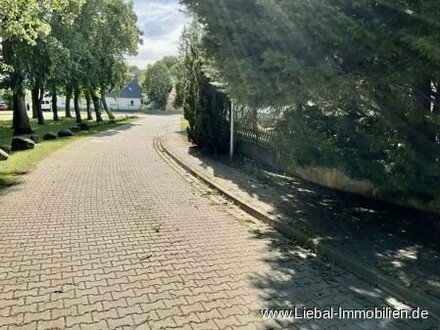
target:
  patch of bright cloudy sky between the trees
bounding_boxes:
[127,0,190,69]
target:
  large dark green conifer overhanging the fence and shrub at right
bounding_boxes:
[181,0,440,153]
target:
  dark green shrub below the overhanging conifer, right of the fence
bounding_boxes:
[277,107,440,202]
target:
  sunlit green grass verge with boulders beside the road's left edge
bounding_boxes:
[0,112,138,188]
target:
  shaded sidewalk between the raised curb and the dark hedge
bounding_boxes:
[184,144,440,324]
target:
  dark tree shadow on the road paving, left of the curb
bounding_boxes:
[242,226,437,330]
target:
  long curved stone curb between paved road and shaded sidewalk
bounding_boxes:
[157,137,440,321]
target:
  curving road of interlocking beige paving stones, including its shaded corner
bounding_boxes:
[0,116,437,330]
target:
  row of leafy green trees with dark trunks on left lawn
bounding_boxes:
[0,0,142,134]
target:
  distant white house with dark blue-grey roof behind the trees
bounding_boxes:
[105,79,144,111]
